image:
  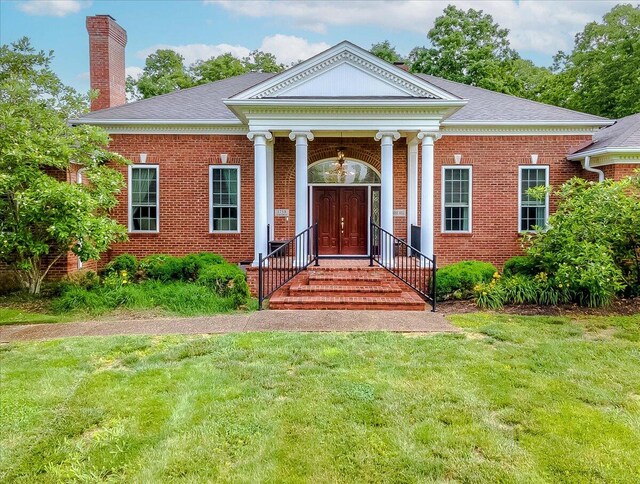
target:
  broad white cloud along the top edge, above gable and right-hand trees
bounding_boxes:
[209,0,618,55]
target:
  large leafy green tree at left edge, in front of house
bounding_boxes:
[0,38,126,294]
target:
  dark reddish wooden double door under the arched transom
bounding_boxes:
[313,187,368,255]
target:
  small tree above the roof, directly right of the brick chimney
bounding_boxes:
[127,49,195,99]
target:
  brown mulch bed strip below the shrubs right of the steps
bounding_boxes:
[436,297,640,316]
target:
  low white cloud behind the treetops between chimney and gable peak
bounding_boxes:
[132,34,330,69]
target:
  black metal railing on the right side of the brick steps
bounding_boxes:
[369,220,436,311]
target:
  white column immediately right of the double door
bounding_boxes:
[375,131,400,265]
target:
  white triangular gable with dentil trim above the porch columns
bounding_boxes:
[231,41,460,100]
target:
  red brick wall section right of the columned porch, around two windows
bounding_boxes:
[435,136,595,267]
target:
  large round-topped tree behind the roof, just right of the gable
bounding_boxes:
[409,5,521,93]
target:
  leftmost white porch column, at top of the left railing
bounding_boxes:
[247,131,273,266]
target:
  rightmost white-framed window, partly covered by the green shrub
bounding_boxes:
[518,166,549,232]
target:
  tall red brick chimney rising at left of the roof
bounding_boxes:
[87,15,127,111]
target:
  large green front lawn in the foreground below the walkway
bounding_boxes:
[0,314,640,483]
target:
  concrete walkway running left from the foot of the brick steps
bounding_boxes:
[0,310,460,343]
